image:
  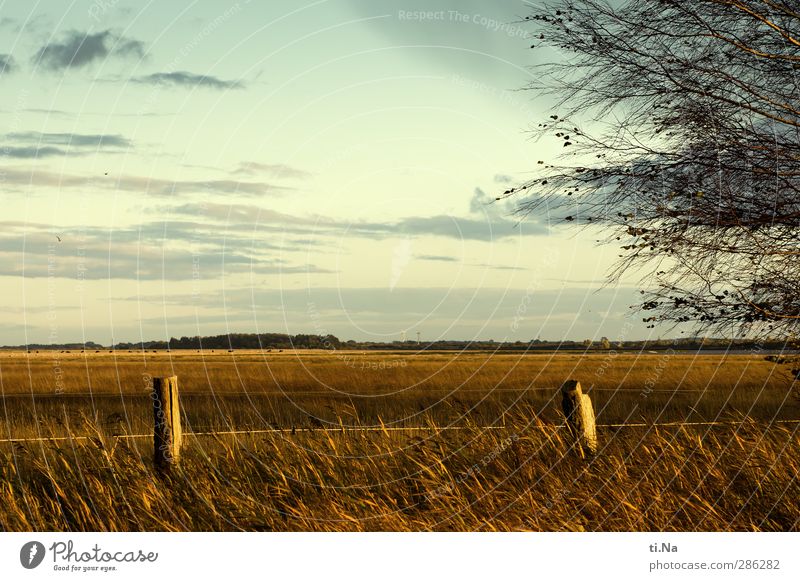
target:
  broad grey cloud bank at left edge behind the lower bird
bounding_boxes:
[0,222,328,281]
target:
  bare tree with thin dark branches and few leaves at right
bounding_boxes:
[504,0,800,336]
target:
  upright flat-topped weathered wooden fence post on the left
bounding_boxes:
[153,376,183,469]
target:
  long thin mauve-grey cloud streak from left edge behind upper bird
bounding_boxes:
[0,165,291,196]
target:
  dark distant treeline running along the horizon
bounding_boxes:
[0,333,797,353]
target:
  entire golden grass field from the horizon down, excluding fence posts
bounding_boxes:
[0,351,800,531]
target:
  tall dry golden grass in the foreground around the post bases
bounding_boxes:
[0,416,800,531]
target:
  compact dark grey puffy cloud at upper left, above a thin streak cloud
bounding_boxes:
[33,30,145,71]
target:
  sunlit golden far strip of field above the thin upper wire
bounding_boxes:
[0,351,789,394]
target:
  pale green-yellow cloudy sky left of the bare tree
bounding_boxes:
[0,0,651,345]
